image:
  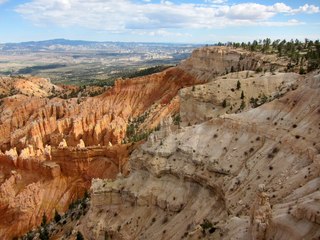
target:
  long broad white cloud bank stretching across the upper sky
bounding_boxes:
[15,0,319,33]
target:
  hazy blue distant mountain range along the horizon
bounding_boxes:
[0,39,201,51]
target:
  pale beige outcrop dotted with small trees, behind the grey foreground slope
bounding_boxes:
[179,71,301,126]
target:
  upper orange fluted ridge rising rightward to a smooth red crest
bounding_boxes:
[0,68,200,151]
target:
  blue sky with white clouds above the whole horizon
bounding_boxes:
[0,0,320,44]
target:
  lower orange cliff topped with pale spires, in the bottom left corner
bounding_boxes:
[0,142,132,239]
